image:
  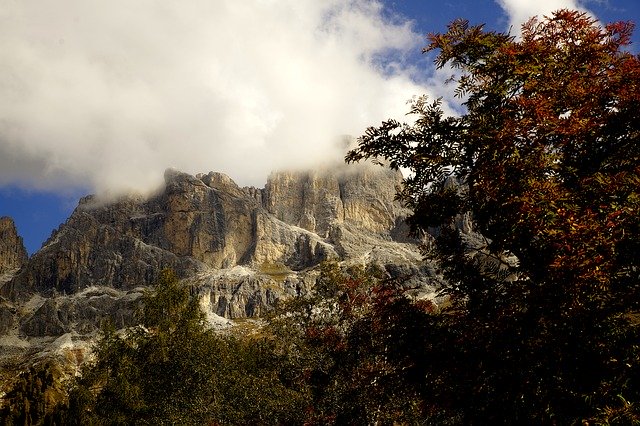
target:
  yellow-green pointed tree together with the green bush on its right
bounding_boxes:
[63,271,308,425]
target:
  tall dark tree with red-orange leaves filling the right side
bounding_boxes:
[347,10,640,423]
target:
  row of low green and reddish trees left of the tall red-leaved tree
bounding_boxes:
[2,263,440,425]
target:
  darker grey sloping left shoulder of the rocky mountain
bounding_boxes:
[2,205,208,299]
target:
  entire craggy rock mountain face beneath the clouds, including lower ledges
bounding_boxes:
[0,161,434,354]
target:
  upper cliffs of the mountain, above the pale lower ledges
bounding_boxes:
[2,166,420,299]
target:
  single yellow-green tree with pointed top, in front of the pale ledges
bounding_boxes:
[68,270,218,424]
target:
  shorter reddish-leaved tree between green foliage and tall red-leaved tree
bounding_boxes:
[268,262,432,425]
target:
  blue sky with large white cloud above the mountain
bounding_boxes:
[0,0,640,253]
